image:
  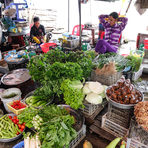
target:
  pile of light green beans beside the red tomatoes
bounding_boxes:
[0,115,21,139]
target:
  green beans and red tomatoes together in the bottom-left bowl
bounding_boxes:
[0,115,25,139]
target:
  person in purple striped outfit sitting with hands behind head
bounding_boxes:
[95,12,128,54]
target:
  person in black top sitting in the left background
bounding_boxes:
[30,17,45,43]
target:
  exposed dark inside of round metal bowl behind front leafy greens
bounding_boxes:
[58,104,85,132]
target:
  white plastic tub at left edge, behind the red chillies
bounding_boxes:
[1,88,22,112]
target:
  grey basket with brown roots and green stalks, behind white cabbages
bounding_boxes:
[91,53,128,86]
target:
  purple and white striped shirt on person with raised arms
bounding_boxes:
[99,15,128,49]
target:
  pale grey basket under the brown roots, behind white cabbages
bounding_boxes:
[91,70,122,86]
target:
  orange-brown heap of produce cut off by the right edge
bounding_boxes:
[134,101,148,132]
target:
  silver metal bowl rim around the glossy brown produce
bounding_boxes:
[105,86,144,109]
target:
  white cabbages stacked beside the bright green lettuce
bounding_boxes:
[83,81,107,105]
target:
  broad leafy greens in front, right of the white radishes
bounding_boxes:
[39,106,76,148]
